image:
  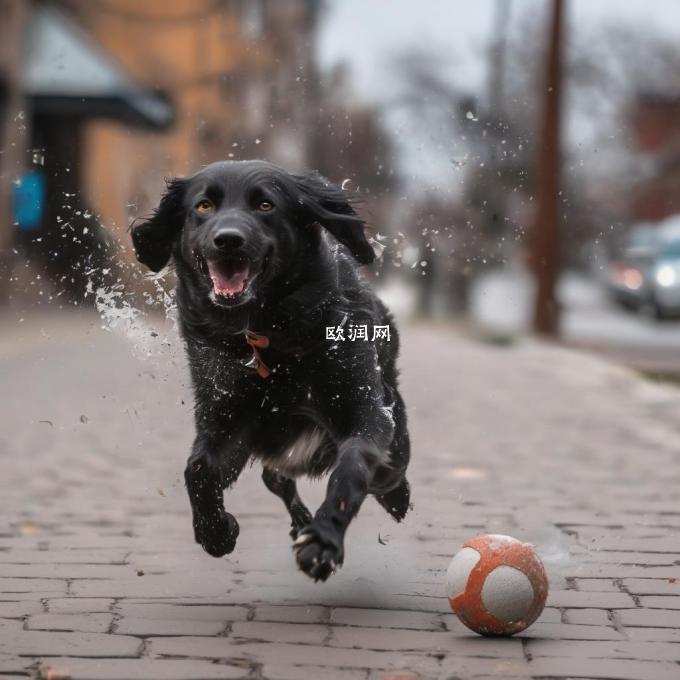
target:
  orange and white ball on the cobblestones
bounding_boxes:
[446,534,548,635]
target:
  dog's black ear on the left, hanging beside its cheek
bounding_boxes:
[131,179,187,272]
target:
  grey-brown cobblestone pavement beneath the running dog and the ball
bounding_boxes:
[0,317,680,680]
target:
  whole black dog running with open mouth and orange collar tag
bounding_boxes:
[132,161,410,580]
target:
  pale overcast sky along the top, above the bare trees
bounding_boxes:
[319,0,680,98]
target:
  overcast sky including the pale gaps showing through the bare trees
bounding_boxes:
[317,0,680,185]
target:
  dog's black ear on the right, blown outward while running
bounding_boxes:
[295,174,375,264]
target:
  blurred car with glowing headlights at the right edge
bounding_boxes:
[608,216,680,319]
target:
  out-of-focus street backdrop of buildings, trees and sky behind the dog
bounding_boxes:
[0,0,680,379]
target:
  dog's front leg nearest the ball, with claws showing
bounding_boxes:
[293,437,382,581]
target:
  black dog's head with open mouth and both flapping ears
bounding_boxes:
[132,161,375,307]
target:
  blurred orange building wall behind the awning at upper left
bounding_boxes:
[68,0,271,258]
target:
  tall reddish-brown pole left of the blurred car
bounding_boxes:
[529,0,564,336]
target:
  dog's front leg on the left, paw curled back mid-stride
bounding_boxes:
[184,435,249,557]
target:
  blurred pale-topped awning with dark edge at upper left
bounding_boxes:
[23,7,173,128]
